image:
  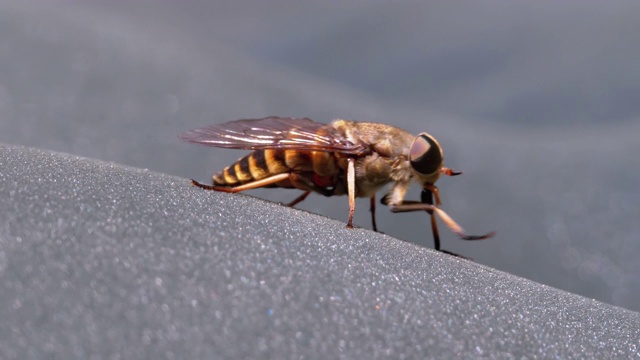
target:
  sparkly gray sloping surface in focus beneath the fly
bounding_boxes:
[0,146,640,359]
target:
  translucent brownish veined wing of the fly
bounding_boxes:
[178,116,368,154]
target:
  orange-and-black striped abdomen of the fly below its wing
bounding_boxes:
[213,149,339,187]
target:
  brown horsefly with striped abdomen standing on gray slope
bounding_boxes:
[179,116,494,255]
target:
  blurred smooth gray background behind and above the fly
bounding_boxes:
[0,0,640,311]
